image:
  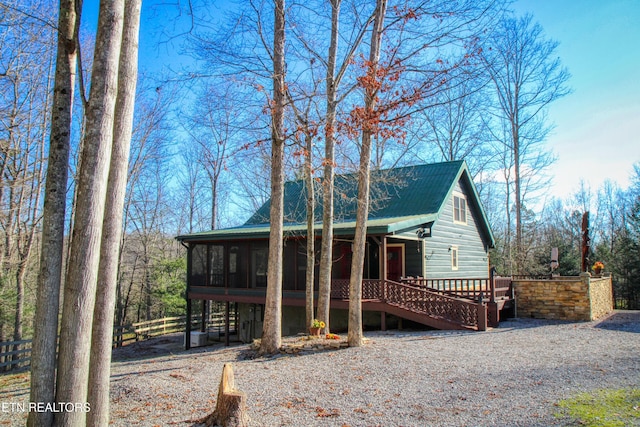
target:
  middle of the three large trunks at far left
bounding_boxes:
[55,0,124,427]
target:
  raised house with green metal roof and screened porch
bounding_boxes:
[177,161,502,348]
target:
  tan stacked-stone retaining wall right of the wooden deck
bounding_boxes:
[513,273,613,321]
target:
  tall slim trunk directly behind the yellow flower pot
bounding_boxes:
[318,0,341,333]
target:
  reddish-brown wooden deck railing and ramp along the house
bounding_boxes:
[189,276,515,331]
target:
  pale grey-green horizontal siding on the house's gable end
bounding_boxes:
[424,182,489,279]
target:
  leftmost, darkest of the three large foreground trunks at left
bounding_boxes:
[27,0,82,426]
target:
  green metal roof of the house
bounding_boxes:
[177,161,494,246]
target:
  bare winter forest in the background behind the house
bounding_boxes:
[0,0,640,350]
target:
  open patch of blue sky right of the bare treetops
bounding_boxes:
[514,0,640,201]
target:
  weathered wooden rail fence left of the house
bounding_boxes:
[0,313,235,373]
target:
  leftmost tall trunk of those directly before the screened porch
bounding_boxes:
[260,0,285,354]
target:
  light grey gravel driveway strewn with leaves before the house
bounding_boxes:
[0,311,640,426]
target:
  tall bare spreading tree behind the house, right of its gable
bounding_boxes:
[484,15,569,274]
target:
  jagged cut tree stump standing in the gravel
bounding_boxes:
[199,363,249,427]
